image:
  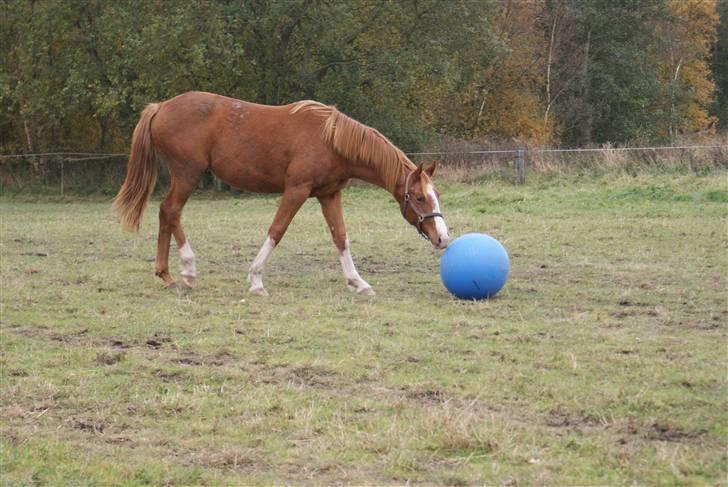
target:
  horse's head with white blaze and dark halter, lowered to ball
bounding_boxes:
[400,162,450,249]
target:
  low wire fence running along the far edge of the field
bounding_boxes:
[0,144,728,194]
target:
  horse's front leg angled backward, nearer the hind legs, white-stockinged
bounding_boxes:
[248,186,311,296]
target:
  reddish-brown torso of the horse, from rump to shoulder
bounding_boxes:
[152,91,338,192]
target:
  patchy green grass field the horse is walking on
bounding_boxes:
[0,172,728,485]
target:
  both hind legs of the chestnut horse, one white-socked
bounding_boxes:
[155,178,197,287]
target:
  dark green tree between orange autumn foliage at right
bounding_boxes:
[560,0,664,145]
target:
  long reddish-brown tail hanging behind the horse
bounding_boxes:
[114,103,160,232]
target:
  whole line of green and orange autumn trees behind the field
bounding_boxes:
[0,0,728,156]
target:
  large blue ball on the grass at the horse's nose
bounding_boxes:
[440,233,510,299]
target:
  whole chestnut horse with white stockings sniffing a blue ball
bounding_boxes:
[114,92,449,295]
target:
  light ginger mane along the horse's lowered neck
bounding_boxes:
[291,100,416,193]
